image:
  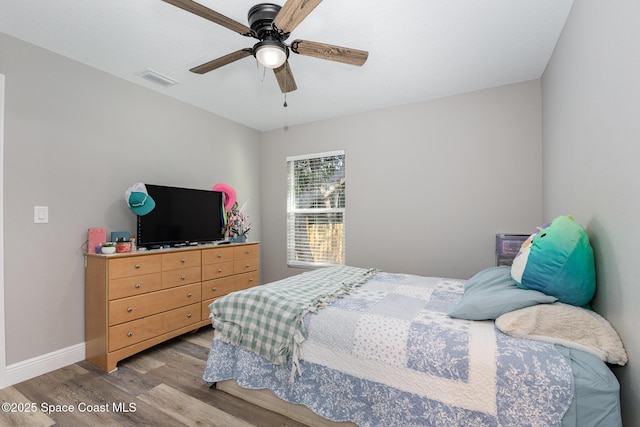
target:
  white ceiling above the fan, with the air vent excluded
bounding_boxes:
[0,0,573,131]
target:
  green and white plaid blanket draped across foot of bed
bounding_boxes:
[209,266,379,380]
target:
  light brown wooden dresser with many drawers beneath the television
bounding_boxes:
[85,243,260,372]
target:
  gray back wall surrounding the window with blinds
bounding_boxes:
[262,81,542,281]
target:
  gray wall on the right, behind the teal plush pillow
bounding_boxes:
[542,0,640,426]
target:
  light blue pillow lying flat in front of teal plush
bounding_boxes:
[449,266,558,320]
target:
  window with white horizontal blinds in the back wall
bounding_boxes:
[287,150,345,267]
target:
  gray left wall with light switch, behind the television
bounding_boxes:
[0,34,261,364]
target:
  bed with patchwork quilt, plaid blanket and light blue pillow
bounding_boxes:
[203,266,626,427]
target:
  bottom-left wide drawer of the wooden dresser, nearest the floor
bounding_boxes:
[109,303,202,351]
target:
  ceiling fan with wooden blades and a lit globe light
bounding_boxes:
[163,0,369,93]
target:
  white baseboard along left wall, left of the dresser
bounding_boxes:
[6,343,86,386]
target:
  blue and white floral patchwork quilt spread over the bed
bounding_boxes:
[204,273,574,426]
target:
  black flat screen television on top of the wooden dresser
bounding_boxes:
[136,184,224,248]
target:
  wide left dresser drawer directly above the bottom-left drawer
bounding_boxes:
[109,283,202,326]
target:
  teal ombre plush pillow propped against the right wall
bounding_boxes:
[511,216,596,306]
